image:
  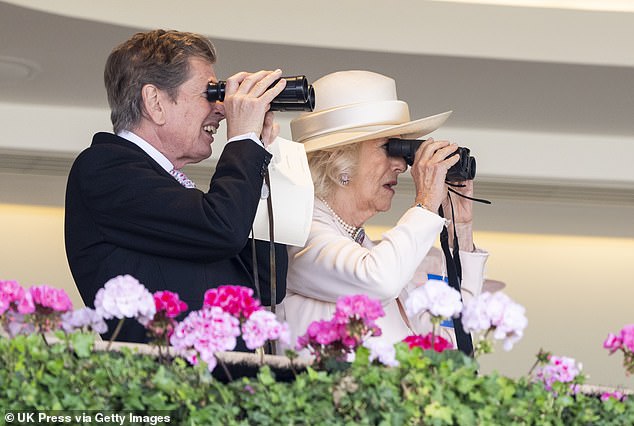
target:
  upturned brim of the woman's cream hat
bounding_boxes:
[302,111,452,152]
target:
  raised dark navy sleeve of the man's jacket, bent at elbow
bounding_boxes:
[67,141,271,262]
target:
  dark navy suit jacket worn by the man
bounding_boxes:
[65,133,288,342]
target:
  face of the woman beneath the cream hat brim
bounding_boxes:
[348,138,407,215]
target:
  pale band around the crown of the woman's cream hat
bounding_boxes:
[291,101,410,142]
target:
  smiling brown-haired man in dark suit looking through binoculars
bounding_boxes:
[65,30,287,342]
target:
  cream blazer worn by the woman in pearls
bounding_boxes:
[277,199,488,347]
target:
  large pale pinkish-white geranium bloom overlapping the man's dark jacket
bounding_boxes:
[95,275,156,319]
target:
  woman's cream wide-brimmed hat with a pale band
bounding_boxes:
[291,71,451,152]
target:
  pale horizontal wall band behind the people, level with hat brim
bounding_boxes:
[0,102,634,190]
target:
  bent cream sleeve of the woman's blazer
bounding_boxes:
[287,207,445,302]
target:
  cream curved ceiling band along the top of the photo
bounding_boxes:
[5,0,634,66]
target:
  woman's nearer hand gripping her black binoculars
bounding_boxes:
[410,138,460,212]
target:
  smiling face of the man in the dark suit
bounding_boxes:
[158,58,225,168]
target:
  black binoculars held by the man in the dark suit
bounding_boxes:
[207,75,315,111]
